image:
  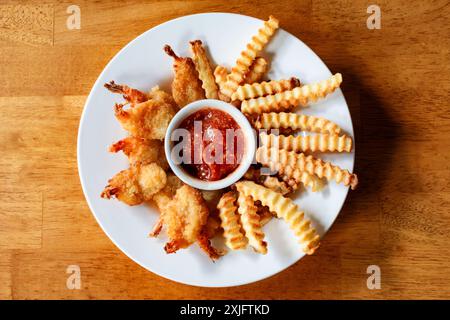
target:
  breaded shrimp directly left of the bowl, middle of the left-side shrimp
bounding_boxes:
[109,136,169,170]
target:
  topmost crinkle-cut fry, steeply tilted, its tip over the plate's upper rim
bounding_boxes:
[222,16,279,97]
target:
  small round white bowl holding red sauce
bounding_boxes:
[164,99,256,190]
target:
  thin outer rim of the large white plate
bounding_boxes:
[77,12,356,288]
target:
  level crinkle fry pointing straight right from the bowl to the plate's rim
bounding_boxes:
[259,132,353,152]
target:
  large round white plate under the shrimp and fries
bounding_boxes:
[78,13,354,287]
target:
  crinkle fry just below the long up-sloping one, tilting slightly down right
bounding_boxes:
[255,112,342,134]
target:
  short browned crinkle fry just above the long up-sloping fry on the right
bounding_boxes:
[231,77,300,101]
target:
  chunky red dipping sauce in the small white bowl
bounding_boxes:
[179,107,245,181]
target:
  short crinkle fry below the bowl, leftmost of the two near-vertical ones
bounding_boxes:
[217,191,247,250]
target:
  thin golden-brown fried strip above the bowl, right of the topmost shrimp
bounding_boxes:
[190,40,218,99]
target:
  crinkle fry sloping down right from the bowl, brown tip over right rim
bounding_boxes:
[256,147,358,190]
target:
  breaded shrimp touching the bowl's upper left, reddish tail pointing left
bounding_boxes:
[115,94,176,140]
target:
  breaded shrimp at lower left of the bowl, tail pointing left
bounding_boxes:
[101,163,167,206]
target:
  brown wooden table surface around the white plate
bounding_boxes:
[0,0,450,299]
